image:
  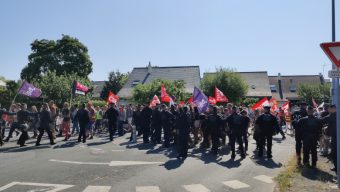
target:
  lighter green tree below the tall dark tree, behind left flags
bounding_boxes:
[32,71,92,107]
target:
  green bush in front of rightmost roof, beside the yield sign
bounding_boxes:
[297,83,331,105]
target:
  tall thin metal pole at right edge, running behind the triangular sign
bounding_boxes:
[332,0,340,189]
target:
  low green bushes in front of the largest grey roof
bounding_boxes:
[133,79,191,103]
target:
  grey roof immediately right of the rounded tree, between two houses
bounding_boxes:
[204,71,272,97]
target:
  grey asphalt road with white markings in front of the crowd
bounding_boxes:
[0,131,294,192]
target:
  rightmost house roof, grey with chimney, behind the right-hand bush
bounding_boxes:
[269,75,324,101]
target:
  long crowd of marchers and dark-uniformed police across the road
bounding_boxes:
[0,101,336,172]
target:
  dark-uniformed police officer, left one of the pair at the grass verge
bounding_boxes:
[292,102,308,165]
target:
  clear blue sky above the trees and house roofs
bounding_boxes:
[0,0,340,80]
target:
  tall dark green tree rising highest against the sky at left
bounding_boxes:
[21,35,92,82]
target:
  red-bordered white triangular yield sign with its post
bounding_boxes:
[320,42,340,189]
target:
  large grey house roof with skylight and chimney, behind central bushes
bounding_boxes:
[118,64,201,98]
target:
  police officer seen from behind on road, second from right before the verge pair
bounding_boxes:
[226,106,246,159]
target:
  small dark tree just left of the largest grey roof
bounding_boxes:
[100,71,129,101]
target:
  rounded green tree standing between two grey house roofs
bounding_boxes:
[201,67,248,103]
